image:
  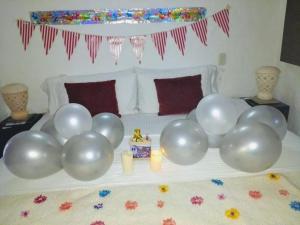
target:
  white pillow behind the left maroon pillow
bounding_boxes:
[42,69,137,114]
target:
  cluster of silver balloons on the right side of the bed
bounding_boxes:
[160,94,287,172]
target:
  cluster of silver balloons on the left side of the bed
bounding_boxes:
[3,103,124,181]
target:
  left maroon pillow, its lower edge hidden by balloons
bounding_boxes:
[65,80,119,116]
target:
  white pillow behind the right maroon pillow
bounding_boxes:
[136,65,218,113]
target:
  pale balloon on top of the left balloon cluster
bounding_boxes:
[54,103,92,139]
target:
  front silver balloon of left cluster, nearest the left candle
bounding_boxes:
[62,131,114,181]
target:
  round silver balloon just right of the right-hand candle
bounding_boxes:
[160,119,208,165]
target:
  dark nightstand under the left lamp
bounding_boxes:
[0,114,44,157]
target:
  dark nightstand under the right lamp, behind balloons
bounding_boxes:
[243,98,290,121]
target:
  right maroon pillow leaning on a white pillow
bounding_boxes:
[154,75,203,115]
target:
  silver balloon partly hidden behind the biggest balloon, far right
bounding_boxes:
[238,105,287,140]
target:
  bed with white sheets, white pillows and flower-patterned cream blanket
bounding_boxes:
[0,66,300,225]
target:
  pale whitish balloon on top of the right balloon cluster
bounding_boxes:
[196,94,238,135]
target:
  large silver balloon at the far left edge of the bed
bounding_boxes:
[3,131,62,179]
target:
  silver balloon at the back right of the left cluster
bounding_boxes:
[92,113,124,149]
